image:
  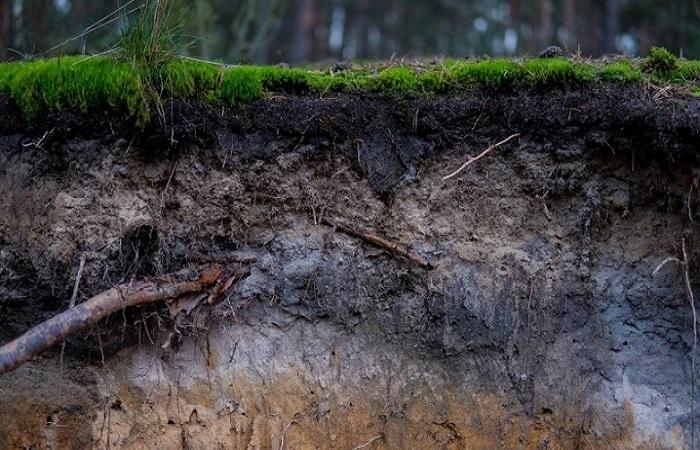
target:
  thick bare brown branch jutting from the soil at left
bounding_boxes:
[0,265,222,375]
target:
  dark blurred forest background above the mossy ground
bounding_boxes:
[0,0,700,64]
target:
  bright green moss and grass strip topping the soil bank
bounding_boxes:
[0,47,700,125]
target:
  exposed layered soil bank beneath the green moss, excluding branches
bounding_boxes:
[0,88,700,449]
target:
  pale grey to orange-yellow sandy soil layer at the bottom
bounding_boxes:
[0,321,685,450]
